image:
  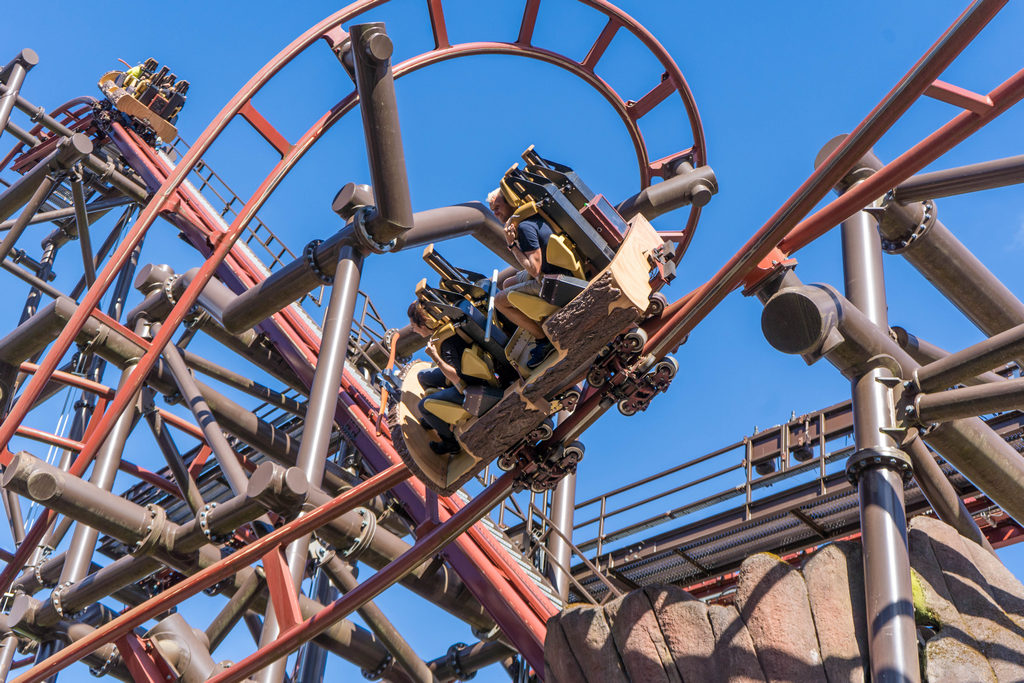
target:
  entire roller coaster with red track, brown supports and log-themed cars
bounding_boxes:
[0,0,1024,683]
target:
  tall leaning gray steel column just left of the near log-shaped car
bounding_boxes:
[257,247,362,683]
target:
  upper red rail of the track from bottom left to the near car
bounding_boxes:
[14,465,412,683]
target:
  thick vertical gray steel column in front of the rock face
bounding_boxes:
[839,200,920,683]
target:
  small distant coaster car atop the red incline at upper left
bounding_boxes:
[98,59,188,142]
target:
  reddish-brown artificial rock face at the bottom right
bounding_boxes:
[545,517,1024,683]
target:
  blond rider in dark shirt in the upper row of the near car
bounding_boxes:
[487,188,572,369]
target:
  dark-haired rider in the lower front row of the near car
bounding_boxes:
[408,301,486,455]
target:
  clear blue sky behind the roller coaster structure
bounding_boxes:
[0,0,1024,681]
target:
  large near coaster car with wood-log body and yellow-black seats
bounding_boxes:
[391,147,666,495]
